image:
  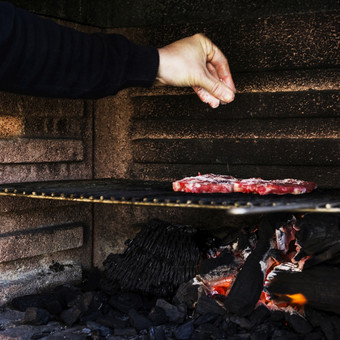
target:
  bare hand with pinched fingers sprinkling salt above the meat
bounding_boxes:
[157,34,236,108]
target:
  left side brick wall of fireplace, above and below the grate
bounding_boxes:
[0,93,93,305]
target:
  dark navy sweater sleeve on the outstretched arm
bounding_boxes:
[0,1,159,98]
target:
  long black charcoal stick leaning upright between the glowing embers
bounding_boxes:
[225,214,280,316]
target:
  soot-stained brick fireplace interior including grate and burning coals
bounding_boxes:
[0,0,340,340]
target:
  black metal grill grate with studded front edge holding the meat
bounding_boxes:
[0,179,340,214]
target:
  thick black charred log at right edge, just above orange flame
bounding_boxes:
[266,265,340,315]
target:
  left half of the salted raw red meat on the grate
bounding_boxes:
[172,174,237,194]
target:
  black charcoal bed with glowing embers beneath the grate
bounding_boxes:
[0,214,340,340]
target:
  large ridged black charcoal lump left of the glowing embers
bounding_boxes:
[104,220,200,297]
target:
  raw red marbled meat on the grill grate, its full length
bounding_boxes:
[172,174,317,195]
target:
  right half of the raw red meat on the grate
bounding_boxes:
[234,178,317,195]
